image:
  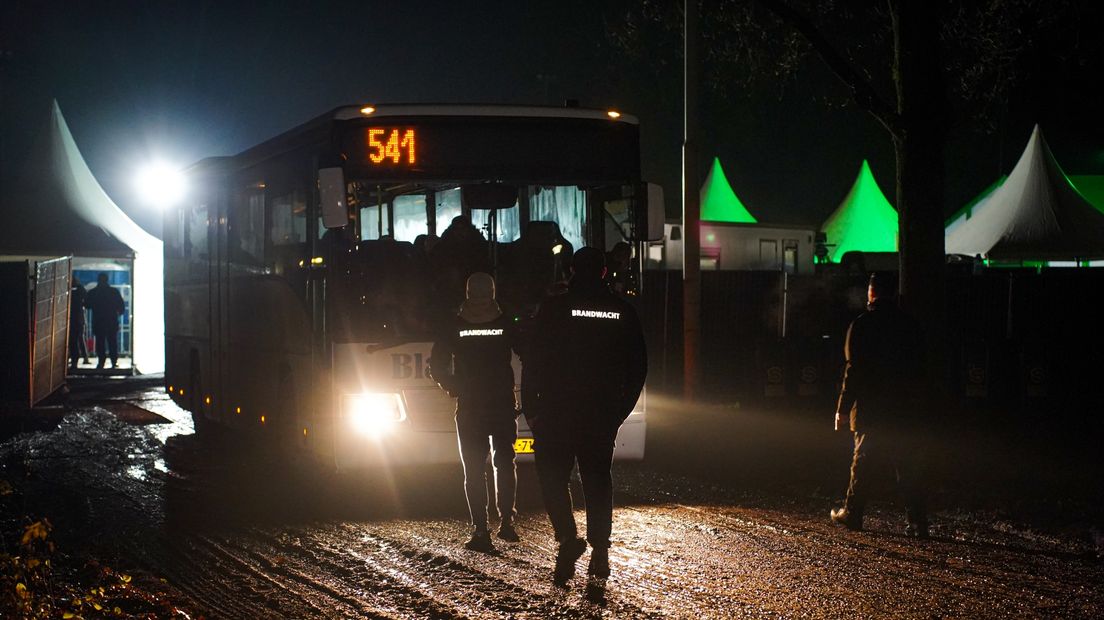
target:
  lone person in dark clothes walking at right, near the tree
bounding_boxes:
[831,274,928,538]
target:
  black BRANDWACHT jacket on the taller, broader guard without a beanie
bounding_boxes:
[521,281,648,429]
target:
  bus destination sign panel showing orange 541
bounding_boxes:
[338,117,640,184]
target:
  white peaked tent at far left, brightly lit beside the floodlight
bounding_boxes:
[0,101,164,373]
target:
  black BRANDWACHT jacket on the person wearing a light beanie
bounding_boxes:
[429,316,517,416]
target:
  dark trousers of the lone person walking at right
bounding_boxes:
[845,432,927,525]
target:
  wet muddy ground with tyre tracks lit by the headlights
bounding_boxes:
[0,378,1104,618]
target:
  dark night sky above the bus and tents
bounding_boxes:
[0,0,1104,234]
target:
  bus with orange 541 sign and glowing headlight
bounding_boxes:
[163,105,662,470]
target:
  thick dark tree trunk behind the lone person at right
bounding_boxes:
[891,0,947,394]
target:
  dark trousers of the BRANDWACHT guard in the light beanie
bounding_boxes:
[456,414,518,530]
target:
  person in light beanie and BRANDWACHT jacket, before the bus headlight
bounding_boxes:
[429,272,518,553]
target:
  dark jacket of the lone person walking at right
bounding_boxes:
[836,300,925,431]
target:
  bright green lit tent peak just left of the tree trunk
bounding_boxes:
[820,160,898,263]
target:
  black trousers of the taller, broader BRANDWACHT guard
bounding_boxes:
[533,427,617,548]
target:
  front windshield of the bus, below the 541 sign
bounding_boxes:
[323,180,604,343]
